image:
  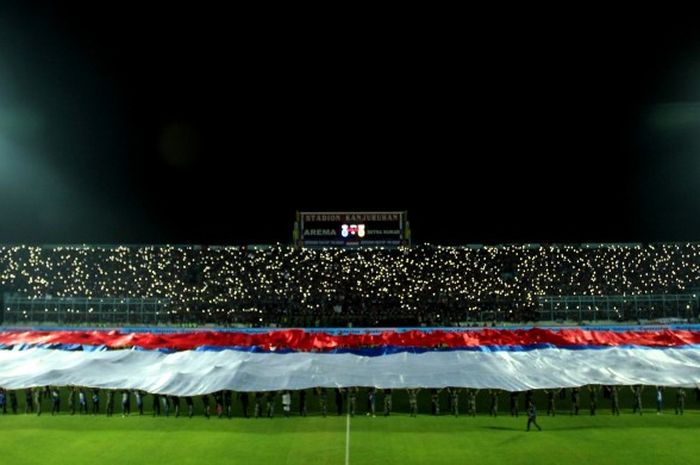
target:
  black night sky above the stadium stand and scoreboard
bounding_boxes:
[0,2,700,244]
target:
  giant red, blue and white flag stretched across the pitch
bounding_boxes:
[0,326,700,396]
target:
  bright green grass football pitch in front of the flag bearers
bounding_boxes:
[0,409,700,465]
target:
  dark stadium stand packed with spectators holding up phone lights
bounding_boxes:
[0,243,700,326]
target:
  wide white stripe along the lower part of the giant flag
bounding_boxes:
[0,347,700,396]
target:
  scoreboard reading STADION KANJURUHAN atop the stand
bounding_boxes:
[294,212,410,247]
